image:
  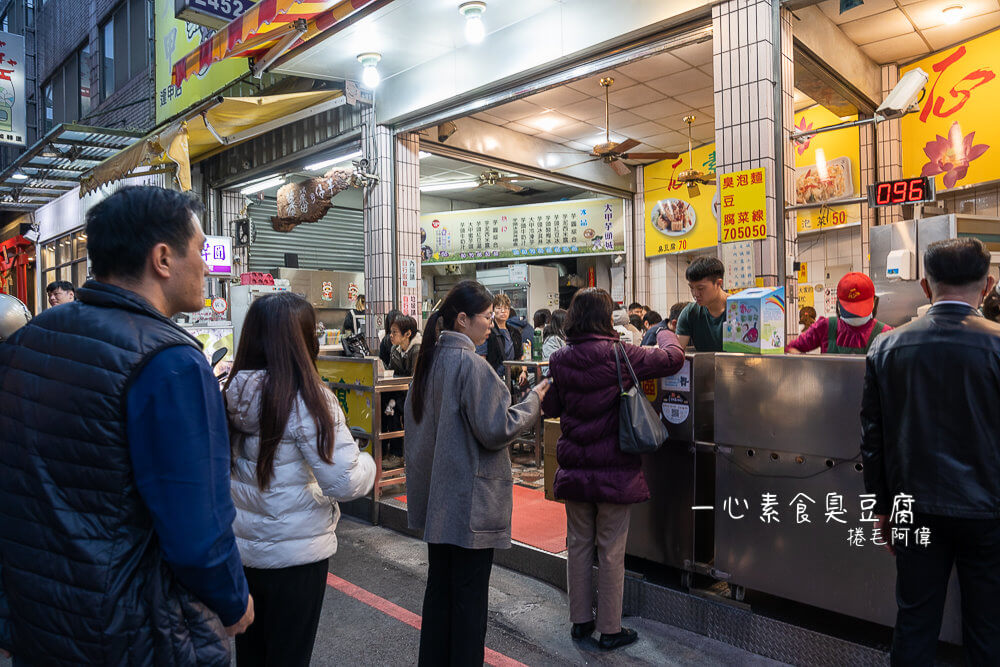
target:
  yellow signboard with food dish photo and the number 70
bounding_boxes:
[643,144,719,257]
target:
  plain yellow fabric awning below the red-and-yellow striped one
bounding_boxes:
[80,90,347,197]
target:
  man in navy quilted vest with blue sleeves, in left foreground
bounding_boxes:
[0,187,253,665]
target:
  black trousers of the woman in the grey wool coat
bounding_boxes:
[417,544,493,667]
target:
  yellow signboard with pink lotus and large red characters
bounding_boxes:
[900,30,1000,190]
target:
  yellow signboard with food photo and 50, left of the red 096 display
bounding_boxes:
[794,104,864,232]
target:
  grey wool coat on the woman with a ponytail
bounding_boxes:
[405,331,541,549]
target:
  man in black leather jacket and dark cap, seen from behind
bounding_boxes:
[861,238,1000,666]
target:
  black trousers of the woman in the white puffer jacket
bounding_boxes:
[236,558,329,667]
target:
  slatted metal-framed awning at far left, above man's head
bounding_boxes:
[0,123,142,211]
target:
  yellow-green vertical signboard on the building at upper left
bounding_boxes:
[154,0,249,124]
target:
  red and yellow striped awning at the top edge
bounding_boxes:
[172,0,375,86]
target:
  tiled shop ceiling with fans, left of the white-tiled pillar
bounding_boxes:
[473,41,715,165]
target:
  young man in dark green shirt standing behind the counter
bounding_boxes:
[676,257,727,352]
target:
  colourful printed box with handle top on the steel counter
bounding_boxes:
[722,287,785,354]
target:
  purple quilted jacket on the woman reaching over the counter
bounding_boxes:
[542,329,684,505]
